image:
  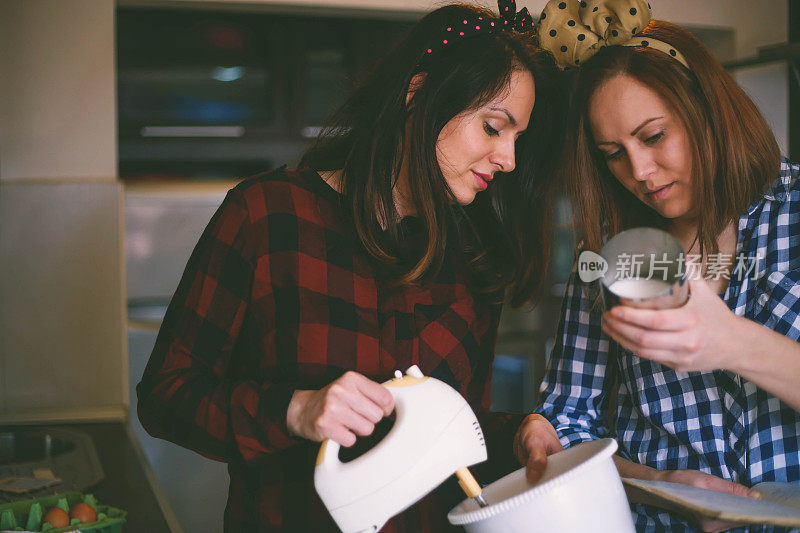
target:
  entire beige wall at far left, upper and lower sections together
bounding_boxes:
[0,0,128,422]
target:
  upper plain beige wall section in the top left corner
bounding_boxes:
[0,0,117,180]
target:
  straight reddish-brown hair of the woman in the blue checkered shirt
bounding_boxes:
[562,21,780,253]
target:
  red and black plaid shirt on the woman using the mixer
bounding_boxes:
[137,169,521,533]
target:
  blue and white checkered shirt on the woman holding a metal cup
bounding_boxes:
[537,159,800,531]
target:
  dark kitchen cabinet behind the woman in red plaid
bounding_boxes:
[117,7,414,180]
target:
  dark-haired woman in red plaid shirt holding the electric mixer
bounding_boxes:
[137,0,563,533]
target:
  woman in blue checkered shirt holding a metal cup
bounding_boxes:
[516,0,800,531]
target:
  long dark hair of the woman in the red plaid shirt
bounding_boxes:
[301,4,565,305]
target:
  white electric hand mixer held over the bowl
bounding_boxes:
[314,365,487,533]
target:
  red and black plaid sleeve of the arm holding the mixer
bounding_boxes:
[136,189,299,462]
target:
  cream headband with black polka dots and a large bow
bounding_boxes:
[539,0,689,68]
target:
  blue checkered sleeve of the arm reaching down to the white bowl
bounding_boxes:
[536,270,609,448]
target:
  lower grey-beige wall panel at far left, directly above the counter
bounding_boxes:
[0,180,128,421]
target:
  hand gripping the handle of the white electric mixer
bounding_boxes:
[286,371,394,447]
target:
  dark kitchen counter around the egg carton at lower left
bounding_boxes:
[0,422,172,533]
